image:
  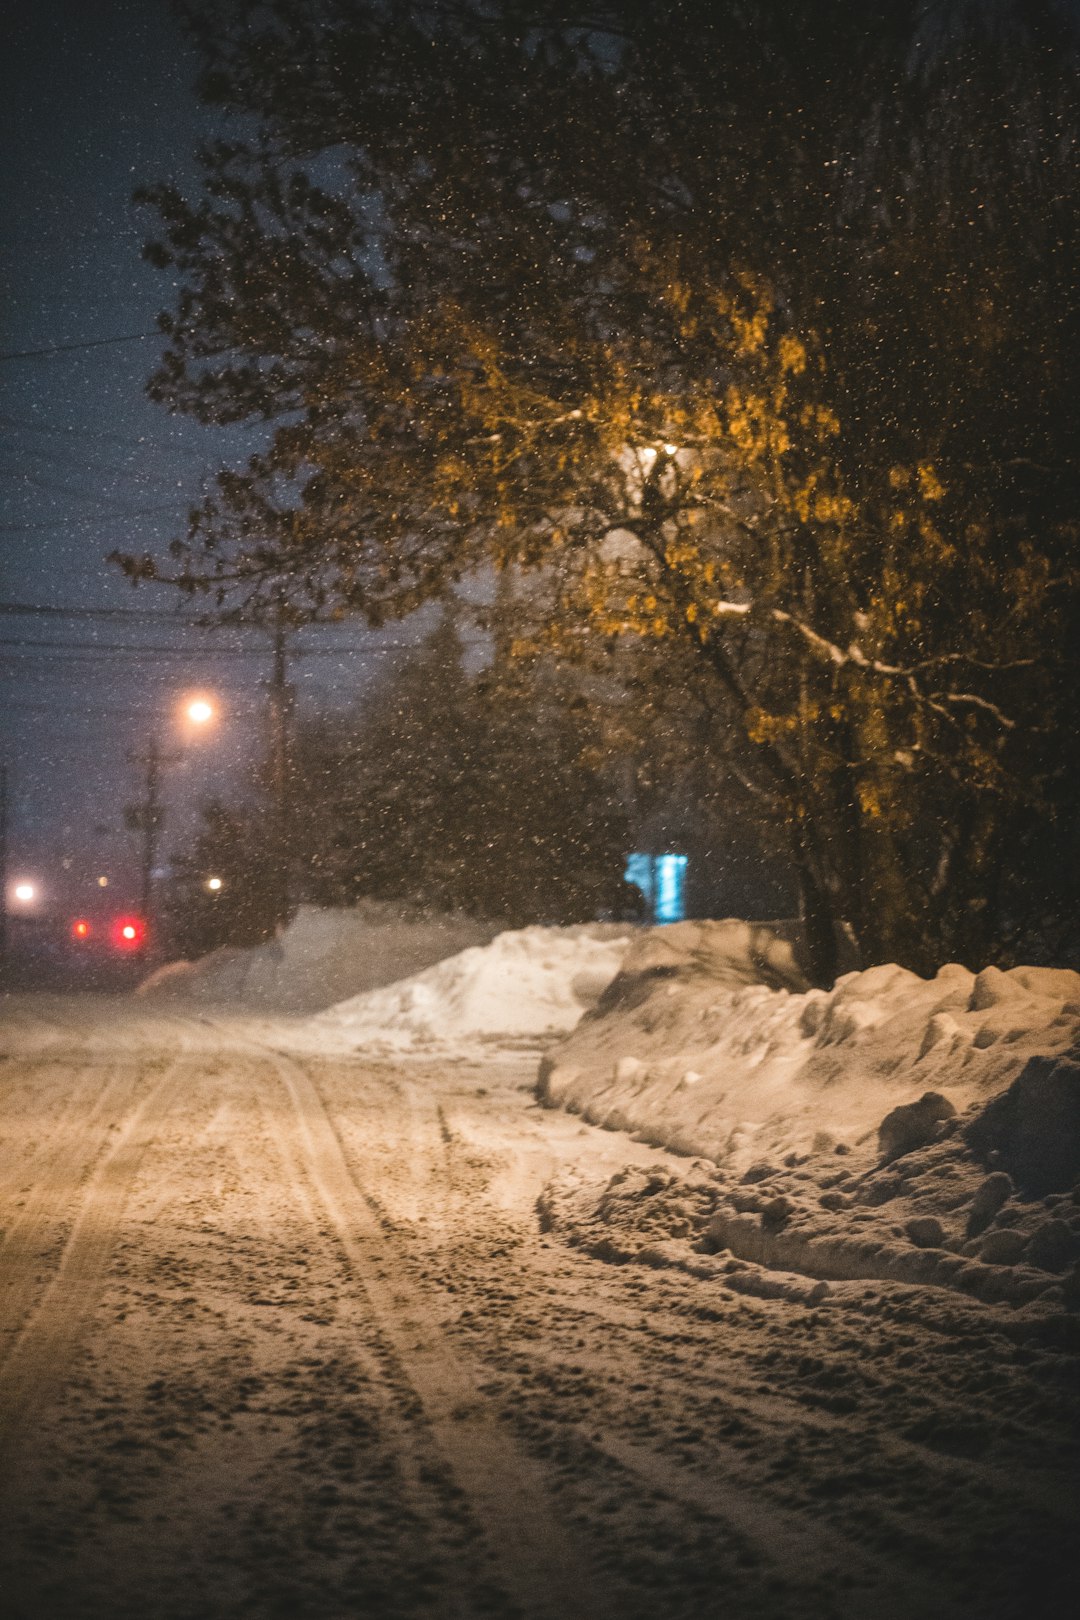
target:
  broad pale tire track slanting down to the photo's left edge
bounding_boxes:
[0,1036,189,1476]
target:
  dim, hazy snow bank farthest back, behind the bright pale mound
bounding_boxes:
[138,901,497,1013]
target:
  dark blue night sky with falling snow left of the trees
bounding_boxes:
[0,0,402,907]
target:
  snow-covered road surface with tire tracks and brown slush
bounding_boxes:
[0,996,1077,1620]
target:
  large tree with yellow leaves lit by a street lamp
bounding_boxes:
[118,0,1077,980]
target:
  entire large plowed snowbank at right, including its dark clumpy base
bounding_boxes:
[539,922,1080,1311]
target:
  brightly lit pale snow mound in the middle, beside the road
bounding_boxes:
[311,923,630,1051]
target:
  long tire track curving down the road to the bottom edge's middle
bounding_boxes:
[269,1053,610,1620]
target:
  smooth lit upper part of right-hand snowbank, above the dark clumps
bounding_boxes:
[541,920,1080,1170]
